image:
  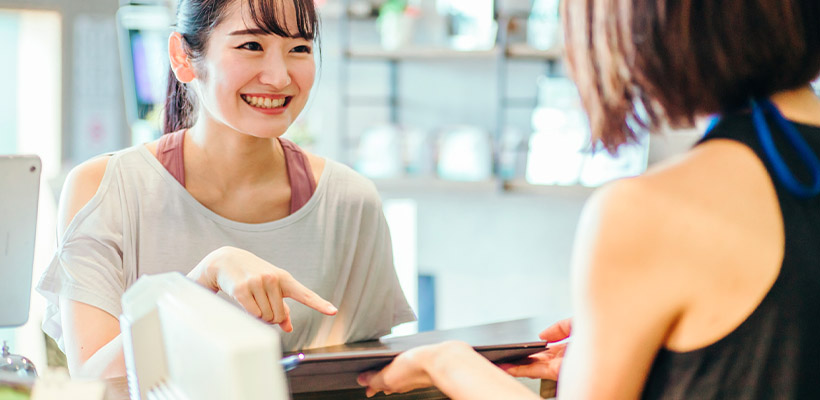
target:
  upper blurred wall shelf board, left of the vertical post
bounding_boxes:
[345,46,498,60]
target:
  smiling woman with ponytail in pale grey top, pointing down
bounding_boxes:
[38,0,415,377]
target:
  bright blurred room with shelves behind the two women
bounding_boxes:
[0,0,812,365]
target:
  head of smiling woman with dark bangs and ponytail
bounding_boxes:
[165,1,318,136]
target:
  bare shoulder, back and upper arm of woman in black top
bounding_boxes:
[559,90,820,398]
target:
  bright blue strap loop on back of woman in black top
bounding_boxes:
[751,99,820,198]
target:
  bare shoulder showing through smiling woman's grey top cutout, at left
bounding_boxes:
[57,156,111,236]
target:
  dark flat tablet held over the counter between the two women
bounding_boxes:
[287,321,547,393]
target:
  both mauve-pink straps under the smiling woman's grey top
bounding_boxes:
[157,129,316,214]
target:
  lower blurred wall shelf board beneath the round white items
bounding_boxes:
[373,177,596,200]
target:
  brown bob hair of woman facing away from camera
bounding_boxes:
[562,0,820,153]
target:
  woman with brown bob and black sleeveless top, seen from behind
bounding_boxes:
[359,0,820,399]
